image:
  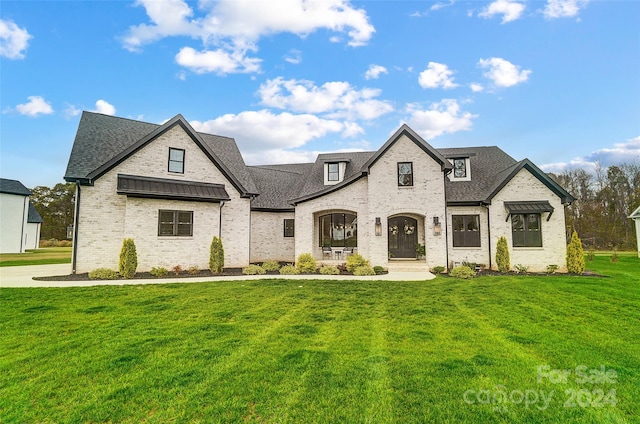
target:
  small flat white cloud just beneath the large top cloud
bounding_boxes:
[176,47,261,75]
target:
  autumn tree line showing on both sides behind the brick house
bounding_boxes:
[31,162,640,250]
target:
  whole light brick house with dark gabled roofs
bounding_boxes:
[65,112,574,272]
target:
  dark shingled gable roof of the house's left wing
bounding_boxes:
[64,111,257,197]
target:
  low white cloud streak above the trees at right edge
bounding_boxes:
[540,136,640,173]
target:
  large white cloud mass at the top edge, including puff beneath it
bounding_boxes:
[122,0,375,73]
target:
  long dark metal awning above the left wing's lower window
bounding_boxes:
[117,174,231,202]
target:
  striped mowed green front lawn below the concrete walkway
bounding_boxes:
[0,255,640,423]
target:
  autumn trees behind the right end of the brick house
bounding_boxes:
[551,162,640,250]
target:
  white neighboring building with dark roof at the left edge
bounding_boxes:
[0,178,42,253]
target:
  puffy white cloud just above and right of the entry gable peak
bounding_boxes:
[407,99,478,139]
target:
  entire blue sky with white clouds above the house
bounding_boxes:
[0,0,640,187]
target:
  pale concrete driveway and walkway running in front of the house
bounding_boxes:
[0,264,435,288]
